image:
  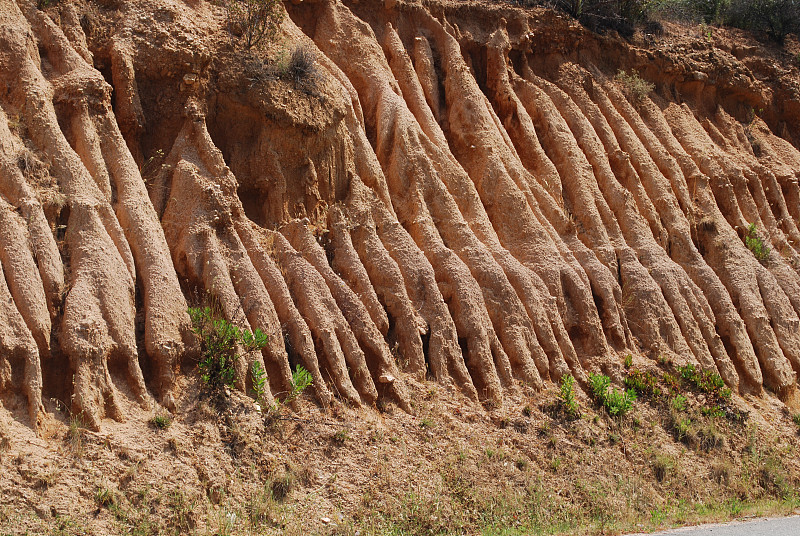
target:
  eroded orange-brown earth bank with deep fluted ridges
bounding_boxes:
[0,0,800,532]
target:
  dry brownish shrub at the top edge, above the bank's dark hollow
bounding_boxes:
[225,0,285,49]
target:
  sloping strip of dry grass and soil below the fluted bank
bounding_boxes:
[0,372,800,536]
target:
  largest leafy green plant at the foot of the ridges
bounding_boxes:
[189,307,268,391]
